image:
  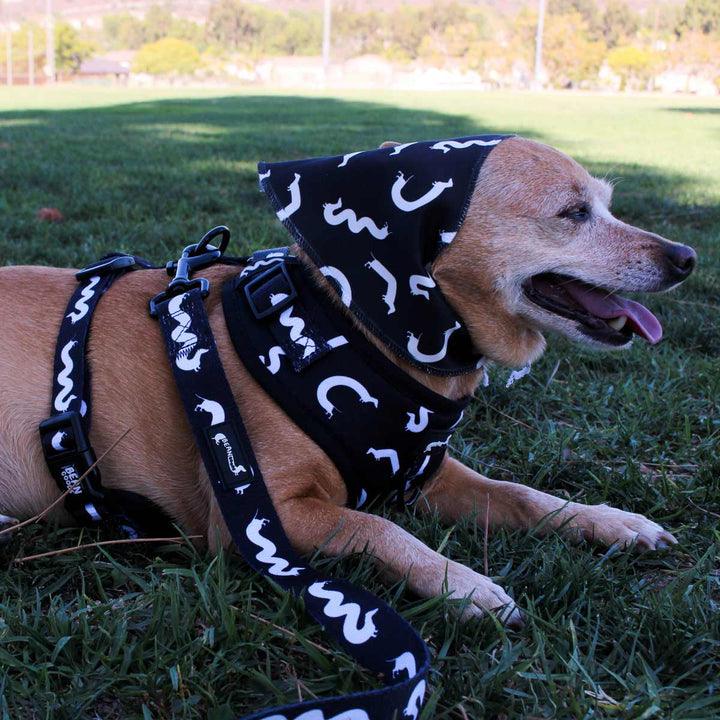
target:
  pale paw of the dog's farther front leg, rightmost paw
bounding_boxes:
[570,504,677,550]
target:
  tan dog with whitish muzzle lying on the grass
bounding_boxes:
[0,138,695,624]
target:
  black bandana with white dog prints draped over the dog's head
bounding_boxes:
[258,135,508,375]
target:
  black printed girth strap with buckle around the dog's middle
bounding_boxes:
[39,253,172,537]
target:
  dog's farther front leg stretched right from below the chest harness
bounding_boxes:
[418,457,677,550]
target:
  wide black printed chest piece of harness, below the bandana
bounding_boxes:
[223,248,469,507]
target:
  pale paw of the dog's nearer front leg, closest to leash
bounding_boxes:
[445,562,524,630]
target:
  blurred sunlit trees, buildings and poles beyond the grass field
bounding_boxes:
[0,0,720,95]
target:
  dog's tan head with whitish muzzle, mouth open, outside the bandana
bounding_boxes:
[433,137,696,365]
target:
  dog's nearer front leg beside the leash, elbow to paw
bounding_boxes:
[277,498,522,627]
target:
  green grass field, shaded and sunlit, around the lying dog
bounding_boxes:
[0,88,720,720]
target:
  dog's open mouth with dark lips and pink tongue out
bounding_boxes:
[523,273,662,346]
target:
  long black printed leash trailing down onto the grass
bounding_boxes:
[153,278,430,720]
